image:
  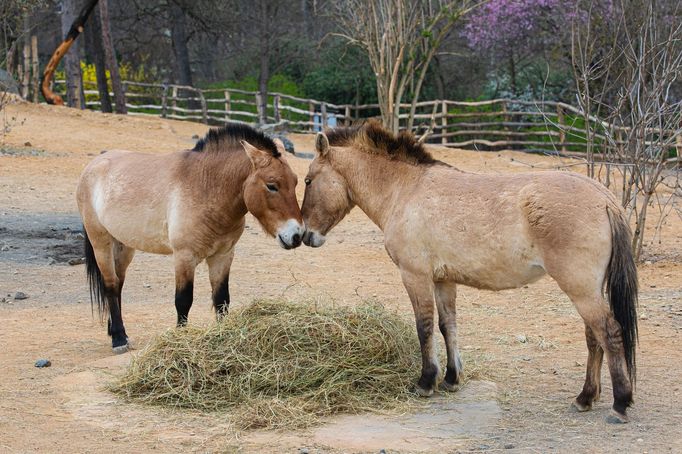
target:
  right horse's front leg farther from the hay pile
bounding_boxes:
[434,281,462,391]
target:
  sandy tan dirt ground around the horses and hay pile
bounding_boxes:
[0,100,682,453]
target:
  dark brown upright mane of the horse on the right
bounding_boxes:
[326,121,440,164]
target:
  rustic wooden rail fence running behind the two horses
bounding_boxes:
[55,81,682,157]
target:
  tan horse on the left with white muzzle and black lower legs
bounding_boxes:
[77,124,304,353]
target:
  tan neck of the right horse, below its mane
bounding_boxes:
[332,148,424,230]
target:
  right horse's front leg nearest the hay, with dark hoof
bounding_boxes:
[401,270,439,397]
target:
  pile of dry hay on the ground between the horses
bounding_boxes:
[113,301,428,428]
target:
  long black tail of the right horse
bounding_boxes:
[604,208,638,387]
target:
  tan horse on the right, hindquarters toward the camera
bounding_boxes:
[302,123,637,422]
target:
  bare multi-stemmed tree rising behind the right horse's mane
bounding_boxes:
[333,0,479,132]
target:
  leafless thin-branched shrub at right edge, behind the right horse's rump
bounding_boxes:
[572,0,682,258]
